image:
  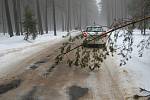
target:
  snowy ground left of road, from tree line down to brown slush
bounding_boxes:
[0,31,79,78]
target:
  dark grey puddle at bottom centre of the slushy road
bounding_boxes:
[68,86,89,100]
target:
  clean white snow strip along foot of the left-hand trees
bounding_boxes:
[0,32,67,50]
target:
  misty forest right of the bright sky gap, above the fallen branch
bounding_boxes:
[100,0,150,27]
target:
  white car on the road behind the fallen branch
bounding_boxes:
[83,26,108,47]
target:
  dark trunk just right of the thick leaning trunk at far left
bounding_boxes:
[13,0,20,36]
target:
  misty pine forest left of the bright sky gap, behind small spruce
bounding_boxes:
[0,0,99,37]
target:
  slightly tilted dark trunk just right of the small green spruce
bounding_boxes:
[36,0,43,35]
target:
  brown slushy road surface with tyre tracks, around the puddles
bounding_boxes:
[0,30,124,100]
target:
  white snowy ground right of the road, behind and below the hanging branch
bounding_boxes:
[115,30,150,97]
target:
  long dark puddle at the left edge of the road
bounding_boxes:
[0,79,22,95]
